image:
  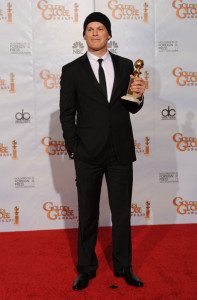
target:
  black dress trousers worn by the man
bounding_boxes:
[74,141,133,274]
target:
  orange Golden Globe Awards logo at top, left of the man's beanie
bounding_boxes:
[37,0,79,24]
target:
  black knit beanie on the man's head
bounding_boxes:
[83,12,112,37]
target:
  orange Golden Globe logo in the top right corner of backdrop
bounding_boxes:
[172,0,197,19]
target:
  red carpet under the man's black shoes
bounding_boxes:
[0,224,197,300]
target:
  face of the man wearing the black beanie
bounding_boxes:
[84,22,111,52]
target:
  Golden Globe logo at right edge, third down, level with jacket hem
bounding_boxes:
[172,133,197,151]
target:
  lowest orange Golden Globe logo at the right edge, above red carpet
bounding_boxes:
[173,197,197,215]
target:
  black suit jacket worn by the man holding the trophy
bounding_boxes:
[60,53,143,164]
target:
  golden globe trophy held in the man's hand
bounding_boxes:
[121,59,144,104]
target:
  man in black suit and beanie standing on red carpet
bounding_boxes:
[60,12,145,290]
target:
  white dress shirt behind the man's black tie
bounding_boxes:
[87,51,114,102]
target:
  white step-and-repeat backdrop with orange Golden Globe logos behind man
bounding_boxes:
[0,0,197,232]
